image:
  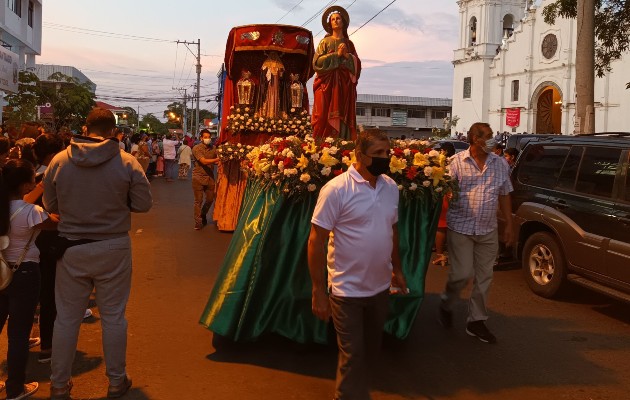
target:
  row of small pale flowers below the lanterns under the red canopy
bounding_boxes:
[227,106,313,137]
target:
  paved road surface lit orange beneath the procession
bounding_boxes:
[0,180,630,400]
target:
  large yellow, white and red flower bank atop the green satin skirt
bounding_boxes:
[245,135,457,199]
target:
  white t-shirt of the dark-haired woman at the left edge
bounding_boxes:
[2,200,48,263]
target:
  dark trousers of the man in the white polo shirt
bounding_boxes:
[330,290,389,400]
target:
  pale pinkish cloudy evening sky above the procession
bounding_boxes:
[42,0,459,122]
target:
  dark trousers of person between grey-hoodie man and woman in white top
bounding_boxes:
[39,254,57,350]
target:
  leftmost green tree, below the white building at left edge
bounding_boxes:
[5,71,41,127]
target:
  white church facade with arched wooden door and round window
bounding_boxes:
[452,0,630,134]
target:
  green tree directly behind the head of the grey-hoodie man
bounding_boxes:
[41,72,95,131]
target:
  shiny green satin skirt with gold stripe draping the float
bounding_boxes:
[200,180,442,344]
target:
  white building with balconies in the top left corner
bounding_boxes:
[0,0,42,69]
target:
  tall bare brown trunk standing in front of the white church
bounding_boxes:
[575,0,595,134]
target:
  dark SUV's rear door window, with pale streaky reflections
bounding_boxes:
[575,147,621,197]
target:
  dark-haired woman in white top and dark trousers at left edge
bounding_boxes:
[0,159,56,400]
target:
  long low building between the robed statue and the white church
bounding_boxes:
[356,94,452,137]
